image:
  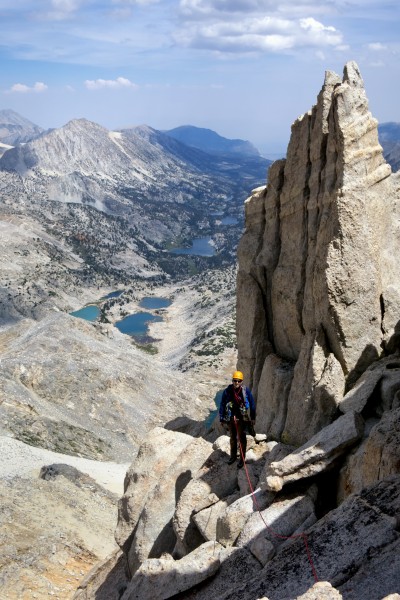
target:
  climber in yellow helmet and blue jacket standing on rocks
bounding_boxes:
[219,371,256,469]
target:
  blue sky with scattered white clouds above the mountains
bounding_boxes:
[0,0,400,155]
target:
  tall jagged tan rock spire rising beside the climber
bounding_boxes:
[237,62,400,444]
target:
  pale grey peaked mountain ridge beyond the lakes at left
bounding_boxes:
[0,119,269,252]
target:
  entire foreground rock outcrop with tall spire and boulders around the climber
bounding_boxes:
[74,62,400,600]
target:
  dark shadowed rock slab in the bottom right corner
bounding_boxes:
[220,476,400,600]
